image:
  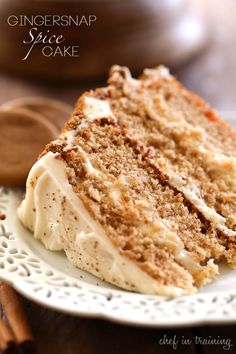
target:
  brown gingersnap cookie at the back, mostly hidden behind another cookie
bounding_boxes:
[0,96,73,130]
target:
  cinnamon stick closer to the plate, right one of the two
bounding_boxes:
[0,282,33,345]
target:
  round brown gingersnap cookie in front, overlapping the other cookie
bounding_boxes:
[0,108,58,187]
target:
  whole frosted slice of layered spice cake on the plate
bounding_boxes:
[18,67,236,296]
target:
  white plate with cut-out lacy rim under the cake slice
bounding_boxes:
[0,112,236,327]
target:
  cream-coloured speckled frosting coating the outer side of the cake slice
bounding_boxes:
[18,152,196,296]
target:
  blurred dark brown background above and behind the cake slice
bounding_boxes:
[0,0,236,110]
